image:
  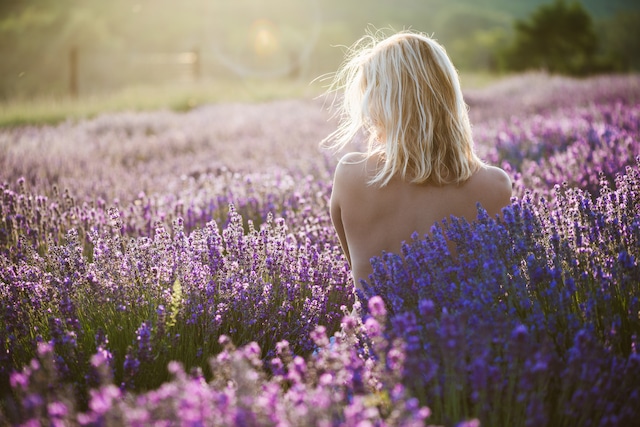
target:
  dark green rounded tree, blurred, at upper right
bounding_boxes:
[502,0,602,75]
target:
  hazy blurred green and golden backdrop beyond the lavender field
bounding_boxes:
[0,0,640,118]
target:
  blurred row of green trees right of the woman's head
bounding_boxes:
[444,0,640,76]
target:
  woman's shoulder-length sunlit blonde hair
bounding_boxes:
[323,31,482,186]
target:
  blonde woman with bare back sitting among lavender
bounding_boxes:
[325,31,512,286]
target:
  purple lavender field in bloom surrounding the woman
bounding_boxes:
[0,74,640,427]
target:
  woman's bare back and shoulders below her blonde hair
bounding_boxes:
[331,153,512,286]
